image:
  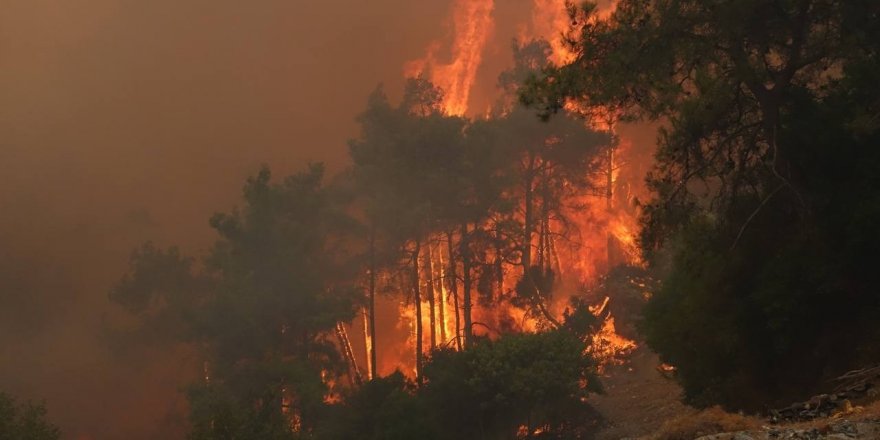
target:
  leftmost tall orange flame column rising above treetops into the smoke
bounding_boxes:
[404,0,495,116]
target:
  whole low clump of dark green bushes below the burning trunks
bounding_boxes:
[316,330,599,439]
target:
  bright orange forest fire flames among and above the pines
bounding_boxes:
[379,0,641,382]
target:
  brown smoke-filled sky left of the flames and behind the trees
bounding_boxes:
[0,0,531,438]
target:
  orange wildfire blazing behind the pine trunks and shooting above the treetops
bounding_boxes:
[362,0,648,382]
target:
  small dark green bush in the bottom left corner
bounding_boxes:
[0,392,61,440]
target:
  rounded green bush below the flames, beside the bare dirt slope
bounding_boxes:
[423,330,598,439]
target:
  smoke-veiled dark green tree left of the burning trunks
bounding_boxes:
[110,165,360,439]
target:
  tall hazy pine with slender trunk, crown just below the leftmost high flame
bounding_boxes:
[351,78,469,382]
